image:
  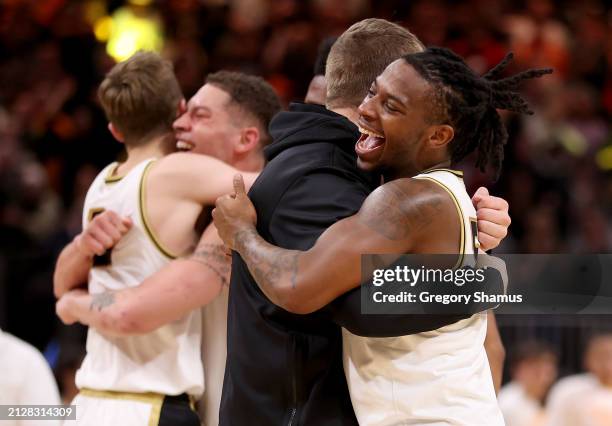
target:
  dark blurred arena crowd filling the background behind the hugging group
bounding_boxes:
[0,0,612,416]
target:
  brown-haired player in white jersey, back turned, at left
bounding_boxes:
[55,52,280,425]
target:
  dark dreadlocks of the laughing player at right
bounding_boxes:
[402,47,552,180]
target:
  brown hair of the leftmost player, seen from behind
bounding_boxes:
[98,51,183,144]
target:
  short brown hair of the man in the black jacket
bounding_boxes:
[325,18,425,108]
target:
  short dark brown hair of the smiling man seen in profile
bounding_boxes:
[206,71,281,146]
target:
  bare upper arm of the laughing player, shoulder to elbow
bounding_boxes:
[296,181,448,311]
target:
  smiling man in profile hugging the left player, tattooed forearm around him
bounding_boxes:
[57,71,280,425]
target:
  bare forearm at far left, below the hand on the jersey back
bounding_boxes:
[53,240,93,298]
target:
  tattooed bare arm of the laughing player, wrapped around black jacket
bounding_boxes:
[214,176,456,313]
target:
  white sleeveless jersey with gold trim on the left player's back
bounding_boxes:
[76,160,204,396]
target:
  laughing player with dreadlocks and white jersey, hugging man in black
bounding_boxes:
[213,48,551,426]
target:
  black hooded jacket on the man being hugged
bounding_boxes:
[220,104,466,426]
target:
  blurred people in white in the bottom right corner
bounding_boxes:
[498,333,612,426]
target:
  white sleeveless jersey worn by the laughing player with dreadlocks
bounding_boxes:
[342,169,504,426]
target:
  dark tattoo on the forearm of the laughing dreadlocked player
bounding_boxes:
[236,229,301,296]
